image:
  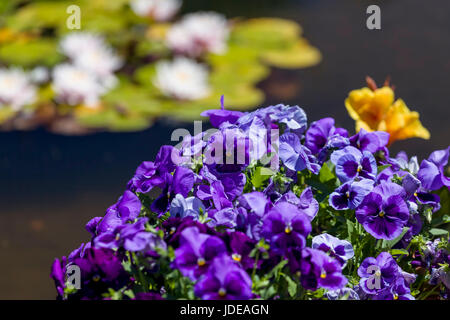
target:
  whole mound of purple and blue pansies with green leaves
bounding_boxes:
[52,105,450,299]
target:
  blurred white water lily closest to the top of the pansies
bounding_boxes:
[154,57,211,100]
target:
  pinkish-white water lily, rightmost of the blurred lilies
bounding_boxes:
[166,12,229,57]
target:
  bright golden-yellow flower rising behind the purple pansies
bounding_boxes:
[345,80,430,144]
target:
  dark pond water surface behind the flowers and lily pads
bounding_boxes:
[0,0,450,299]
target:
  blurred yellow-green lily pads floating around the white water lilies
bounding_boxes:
[0,0,321,134]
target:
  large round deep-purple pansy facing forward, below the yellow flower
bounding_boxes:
[356,182,409,240]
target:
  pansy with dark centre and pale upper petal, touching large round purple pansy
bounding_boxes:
[329,179,374,210]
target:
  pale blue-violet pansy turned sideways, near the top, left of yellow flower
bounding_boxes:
[279,132,320,174]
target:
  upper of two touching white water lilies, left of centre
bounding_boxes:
[60,32,122,78]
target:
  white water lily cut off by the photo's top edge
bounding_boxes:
[130,0,182,21]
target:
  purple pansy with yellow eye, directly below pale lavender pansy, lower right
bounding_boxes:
[300,248,347,290]
